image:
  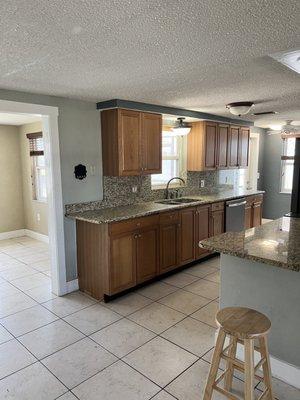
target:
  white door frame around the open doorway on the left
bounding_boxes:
[0,100,68,296]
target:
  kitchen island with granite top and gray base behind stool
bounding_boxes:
[199,217,300,388]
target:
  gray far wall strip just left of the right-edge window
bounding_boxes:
[263,134,291,219]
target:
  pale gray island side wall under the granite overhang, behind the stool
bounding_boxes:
[220,254,300,368]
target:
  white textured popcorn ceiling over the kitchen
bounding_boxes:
[0,0,300,124]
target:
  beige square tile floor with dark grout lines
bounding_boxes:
[0,237,300,400]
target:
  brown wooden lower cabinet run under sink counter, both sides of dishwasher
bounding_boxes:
[76,195,263,300]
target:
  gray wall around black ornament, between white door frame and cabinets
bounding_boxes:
[0,90,102,281]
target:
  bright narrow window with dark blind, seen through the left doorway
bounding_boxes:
[27,132,47,202]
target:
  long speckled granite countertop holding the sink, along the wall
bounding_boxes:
[66,190,264,224]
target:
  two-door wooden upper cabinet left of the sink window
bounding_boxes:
[101,109,162,176]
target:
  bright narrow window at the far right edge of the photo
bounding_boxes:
[280,138,295,193]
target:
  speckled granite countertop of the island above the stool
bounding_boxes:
[199,217,300,272]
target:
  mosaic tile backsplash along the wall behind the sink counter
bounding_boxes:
[66,169,245,213]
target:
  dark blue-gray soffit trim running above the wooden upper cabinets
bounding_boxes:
[97,99,254,126]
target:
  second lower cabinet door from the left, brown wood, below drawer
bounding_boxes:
[136,227,158,283]
